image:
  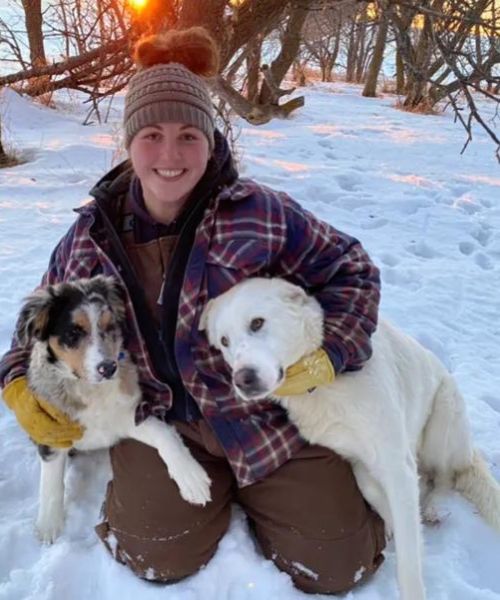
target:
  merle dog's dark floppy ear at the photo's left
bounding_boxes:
[16,286,55,346]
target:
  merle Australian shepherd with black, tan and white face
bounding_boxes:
[17,275,210,543]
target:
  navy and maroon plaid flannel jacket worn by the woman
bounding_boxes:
[0,179,380,486]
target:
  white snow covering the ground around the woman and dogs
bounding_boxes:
[0,83,500,600]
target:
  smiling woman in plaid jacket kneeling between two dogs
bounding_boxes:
[0,28,384,593]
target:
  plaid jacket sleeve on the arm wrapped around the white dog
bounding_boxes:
[280,197,380,373]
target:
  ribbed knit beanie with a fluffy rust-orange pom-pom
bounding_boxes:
[123,27,219,151]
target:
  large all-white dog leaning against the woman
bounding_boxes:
[200,278,500,600]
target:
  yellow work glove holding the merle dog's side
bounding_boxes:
[3,377,83,448]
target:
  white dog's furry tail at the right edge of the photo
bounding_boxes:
[454,449,500,532]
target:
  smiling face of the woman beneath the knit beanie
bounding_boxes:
[129,123,210,224]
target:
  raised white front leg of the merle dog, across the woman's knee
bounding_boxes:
[128,417,211,505]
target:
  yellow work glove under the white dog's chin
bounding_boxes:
[273,348,335,396]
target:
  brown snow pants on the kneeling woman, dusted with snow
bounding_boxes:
[96,421,385,594]
